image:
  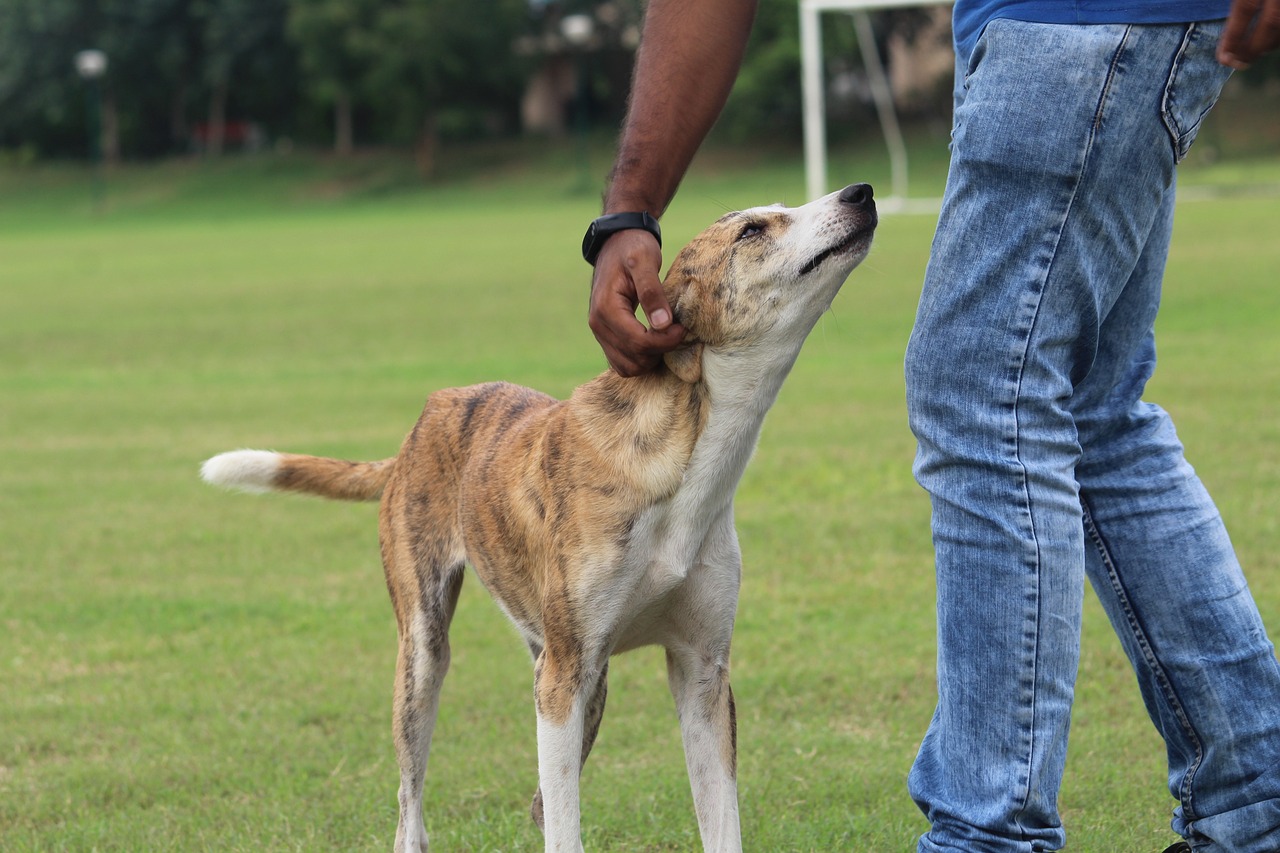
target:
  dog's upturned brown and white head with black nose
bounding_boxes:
[663,184,877,382]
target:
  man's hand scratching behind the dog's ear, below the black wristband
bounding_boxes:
[589,229,685,377]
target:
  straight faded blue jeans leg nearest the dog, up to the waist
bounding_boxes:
[906,20,1275,852]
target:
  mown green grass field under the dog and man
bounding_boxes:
[0,136,1280,853]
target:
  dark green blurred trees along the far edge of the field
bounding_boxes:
[0,0,1280,163]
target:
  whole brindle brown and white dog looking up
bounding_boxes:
[202,184,878,852]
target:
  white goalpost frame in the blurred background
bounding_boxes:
[800,0,947,211]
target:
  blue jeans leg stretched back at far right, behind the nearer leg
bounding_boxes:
[1073,184,1280,853]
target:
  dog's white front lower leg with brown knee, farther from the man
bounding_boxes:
[534,646,595,853]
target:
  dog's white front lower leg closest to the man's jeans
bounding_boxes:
[667,647,742,853]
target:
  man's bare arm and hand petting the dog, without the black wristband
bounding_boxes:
[589,0,755,377]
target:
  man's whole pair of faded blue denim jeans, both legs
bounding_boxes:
[906,20,1280,853]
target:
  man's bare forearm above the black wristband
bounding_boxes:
[604,0,756,216]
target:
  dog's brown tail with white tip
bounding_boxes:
[200,450,396,501]
